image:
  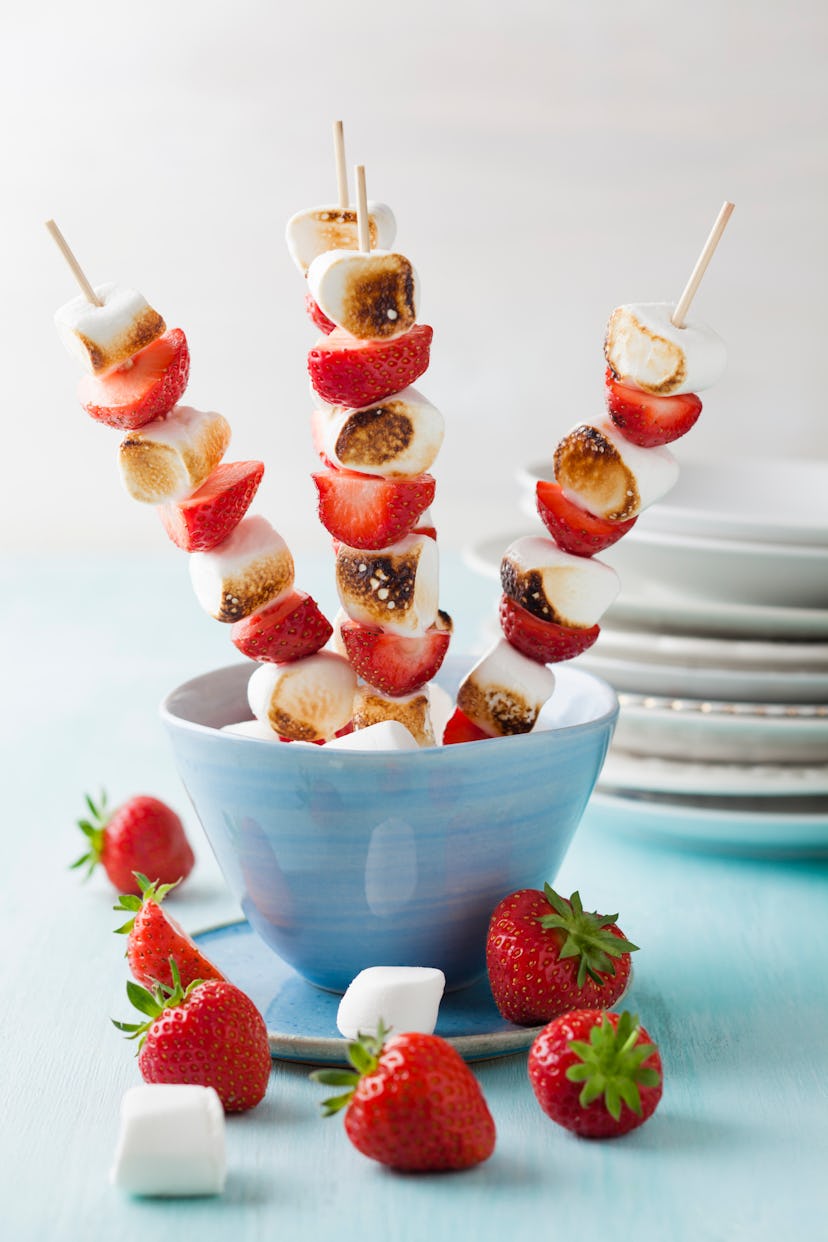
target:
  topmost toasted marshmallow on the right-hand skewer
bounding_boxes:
[603,302,727,396]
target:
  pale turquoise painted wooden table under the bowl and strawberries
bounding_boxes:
[0,548,828,1242]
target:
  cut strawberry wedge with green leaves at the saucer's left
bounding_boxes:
[113,872,225,987]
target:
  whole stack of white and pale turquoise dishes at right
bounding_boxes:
[472,461,828,852]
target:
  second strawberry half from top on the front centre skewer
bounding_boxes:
[312,469,436,548]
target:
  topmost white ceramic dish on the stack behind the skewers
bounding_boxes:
[518,460,828,548]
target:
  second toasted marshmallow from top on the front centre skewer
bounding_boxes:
[312,388,446,478]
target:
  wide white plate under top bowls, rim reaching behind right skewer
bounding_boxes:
[463,531,828,640]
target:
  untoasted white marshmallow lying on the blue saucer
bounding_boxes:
[336,966,446,1040]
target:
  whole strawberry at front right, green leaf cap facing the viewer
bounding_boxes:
[528,1010,662,1139]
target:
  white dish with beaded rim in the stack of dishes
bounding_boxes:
[613,694,828,764]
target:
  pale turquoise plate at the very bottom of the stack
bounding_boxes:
[580,792,828,856]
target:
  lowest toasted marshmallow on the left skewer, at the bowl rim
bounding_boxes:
[247,651,356,741]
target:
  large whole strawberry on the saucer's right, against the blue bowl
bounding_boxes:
[485,884,638,1026]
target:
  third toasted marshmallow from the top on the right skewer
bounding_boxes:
[500,535,621,627]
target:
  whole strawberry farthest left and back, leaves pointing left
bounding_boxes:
[72,794,195,895]
